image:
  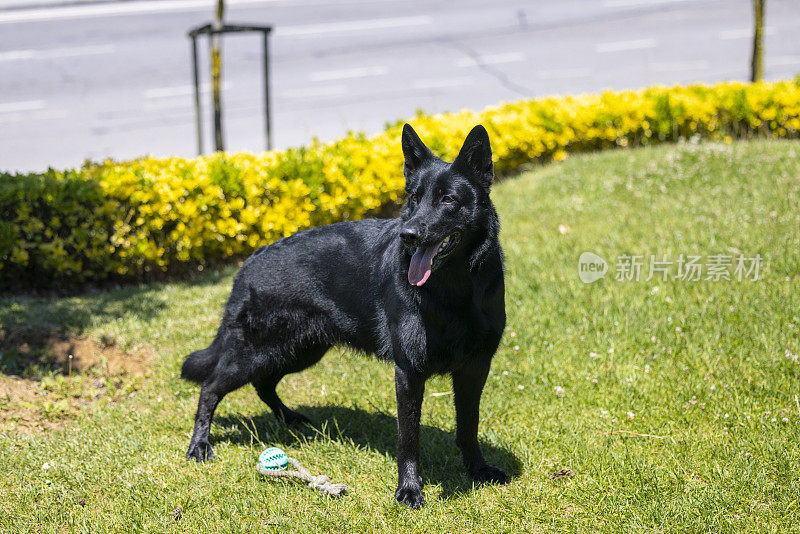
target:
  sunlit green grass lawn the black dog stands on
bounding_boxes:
[0,141,800,534]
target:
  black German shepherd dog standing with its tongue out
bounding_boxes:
[182,124,507,508]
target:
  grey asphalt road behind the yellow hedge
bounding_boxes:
[0,0,800,171]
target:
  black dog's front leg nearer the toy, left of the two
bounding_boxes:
[394,366,425,509]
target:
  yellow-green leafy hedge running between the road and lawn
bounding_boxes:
[0,80,800,289]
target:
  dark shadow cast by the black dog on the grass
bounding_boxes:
[216,406,522,499]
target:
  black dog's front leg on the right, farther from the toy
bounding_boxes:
[453,365,508,484]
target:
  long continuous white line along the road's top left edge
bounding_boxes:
[0,0,276,24]
